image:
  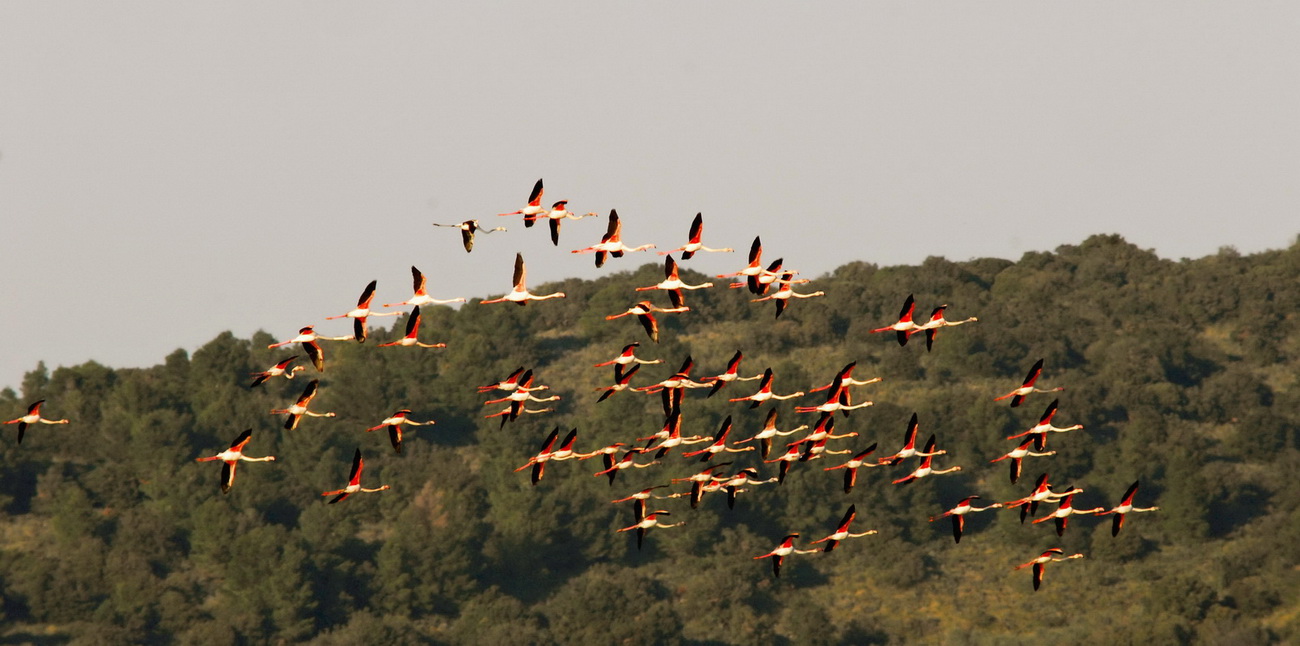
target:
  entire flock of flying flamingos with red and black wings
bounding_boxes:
[4,179,1157,590]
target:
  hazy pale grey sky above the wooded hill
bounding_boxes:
[0,0,1300,387]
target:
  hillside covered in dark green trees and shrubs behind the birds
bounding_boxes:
[0,237,1300,645]
